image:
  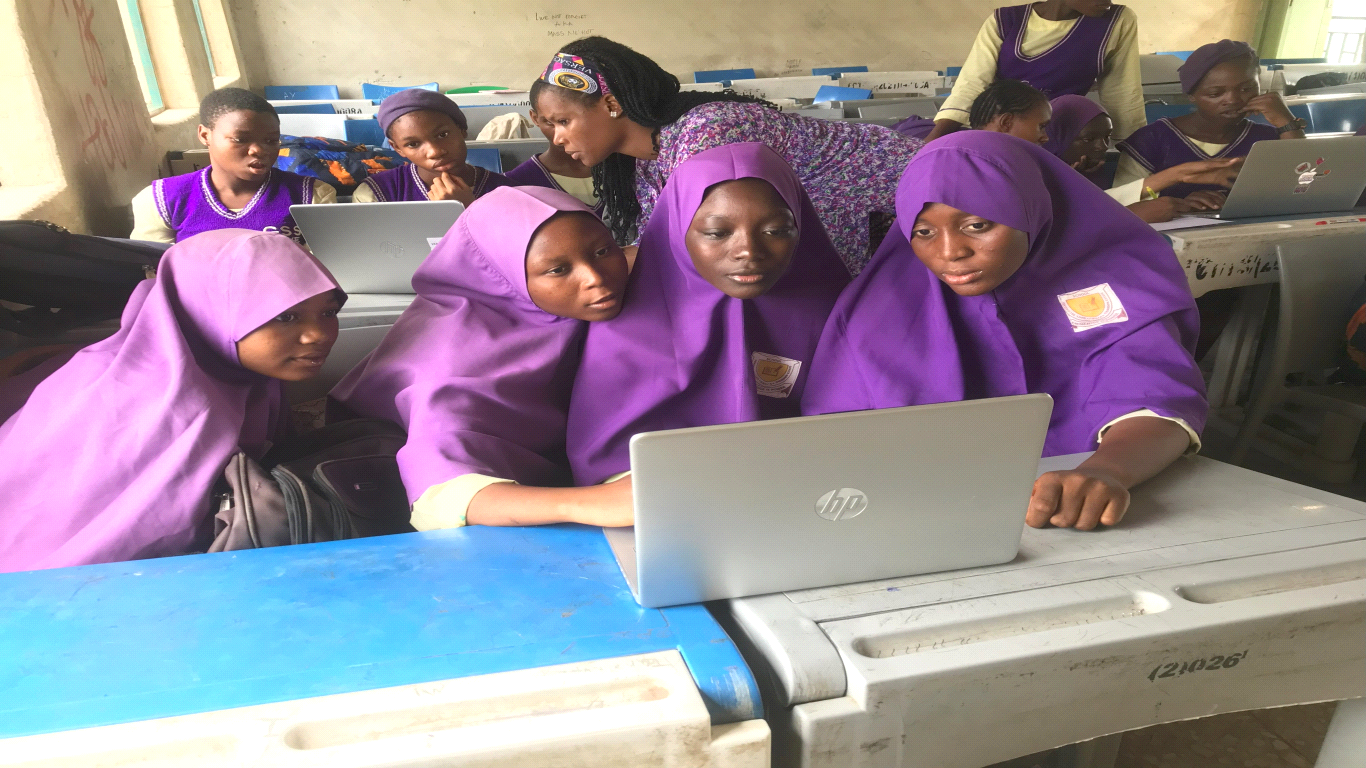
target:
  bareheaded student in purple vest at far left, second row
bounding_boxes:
[130,87,337,243]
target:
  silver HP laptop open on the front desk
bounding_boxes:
[604,395,1053,608]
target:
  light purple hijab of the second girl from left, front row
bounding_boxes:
[332,187,596,502]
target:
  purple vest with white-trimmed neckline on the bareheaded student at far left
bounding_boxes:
[152,165,313,243]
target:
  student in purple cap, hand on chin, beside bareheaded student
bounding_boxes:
[351,87,514,205]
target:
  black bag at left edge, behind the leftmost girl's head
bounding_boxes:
[0,221,171,336]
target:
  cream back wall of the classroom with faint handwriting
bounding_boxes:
[229,0,1264,97]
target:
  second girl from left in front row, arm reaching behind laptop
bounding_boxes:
[332,187,631,530]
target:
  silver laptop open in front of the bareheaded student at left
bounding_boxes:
[290,200,464,294]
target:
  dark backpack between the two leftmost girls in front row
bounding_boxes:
[209,418,414,552]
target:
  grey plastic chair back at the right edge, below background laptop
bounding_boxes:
[1272,232,1366,384]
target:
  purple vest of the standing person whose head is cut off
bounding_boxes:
[996,4,1124,98]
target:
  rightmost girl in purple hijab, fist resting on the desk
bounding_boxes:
[802,131,1206,529]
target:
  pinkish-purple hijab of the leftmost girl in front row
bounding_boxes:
[0,230,339,571]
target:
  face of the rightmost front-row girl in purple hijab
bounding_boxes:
[911,202,1029,297]
